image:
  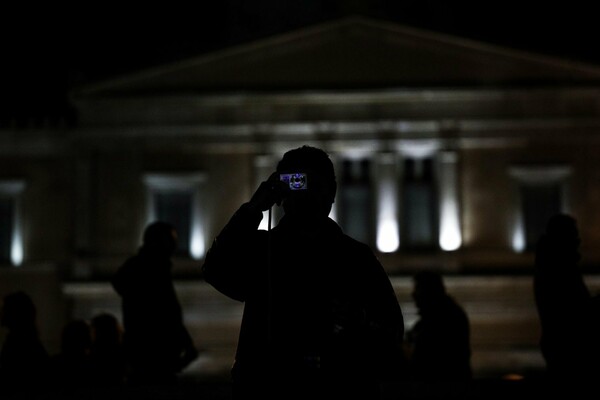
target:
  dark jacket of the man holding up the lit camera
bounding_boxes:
[203,206,404,390]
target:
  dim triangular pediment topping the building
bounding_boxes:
[74,17,600,96]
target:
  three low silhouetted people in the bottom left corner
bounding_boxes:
[0,290,126,398]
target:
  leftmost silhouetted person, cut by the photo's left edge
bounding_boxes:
[0,290,50,392]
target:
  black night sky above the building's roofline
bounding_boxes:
[0,0,600,122]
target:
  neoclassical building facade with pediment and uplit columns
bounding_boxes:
[0,18,600,374]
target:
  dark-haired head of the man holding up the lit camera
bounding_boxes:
[277,145,337,217]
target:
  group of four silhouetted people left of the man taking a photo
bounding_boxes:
[0,222,198,397]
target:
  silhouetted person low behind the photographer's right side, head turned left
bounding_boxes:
[405,271,472,382]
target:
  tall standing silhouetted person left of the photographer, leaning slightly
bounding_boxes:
[111,221,198,385]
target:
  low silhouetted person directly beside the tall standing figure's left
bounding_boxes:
[91,313,127,387]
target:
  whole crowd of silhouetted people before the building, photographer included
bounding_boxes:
[0,146,600,400]
